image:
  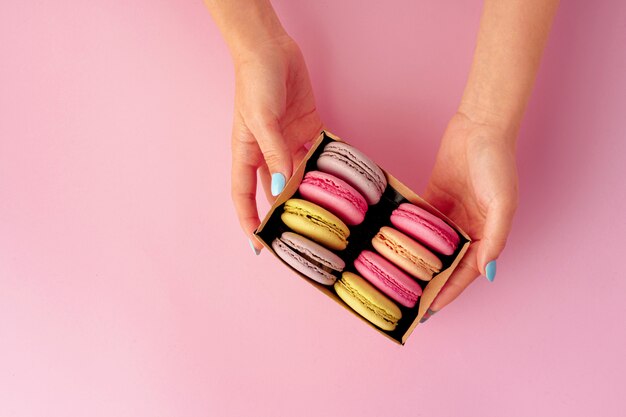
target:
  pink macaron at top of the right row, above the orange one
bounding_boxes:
[391,203,460,255]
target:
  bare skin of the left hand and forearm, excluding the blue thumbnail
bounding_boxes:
[205,0,323,236]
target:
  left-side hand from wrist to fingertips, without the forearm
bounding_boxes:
[231,35,322,254]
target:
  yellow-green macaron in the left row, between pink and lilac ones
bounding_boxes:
[280,198,350,250]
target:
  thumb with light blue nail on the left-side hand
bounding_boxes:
[250,117,292,196]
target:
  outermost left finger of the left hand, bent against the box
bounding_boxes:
[231,128,262,252]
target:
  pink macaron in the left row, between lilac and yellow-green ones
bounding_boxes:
[298,171,367,226]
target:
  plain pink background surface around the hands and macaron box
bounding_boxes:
[0,0,626,417]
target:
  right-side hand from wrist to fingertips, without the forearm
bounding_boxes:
[425,112,517,319]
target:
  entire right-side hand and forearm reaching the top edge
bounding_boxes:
[424,0,559,319]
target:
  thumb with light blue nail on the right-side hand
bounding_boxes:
[476,198,517,281]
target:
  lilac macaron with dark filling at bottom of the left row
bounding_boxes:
[272,232,346,285]
